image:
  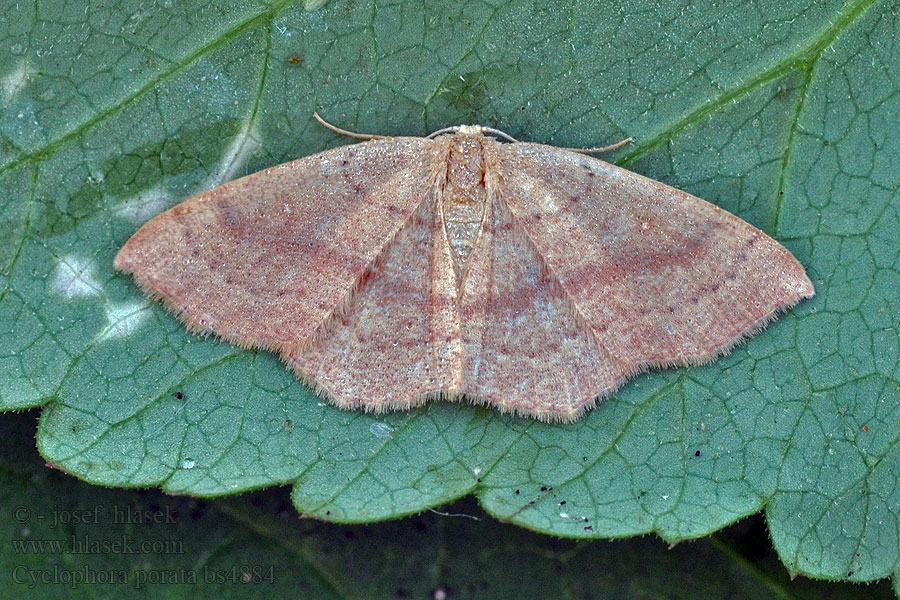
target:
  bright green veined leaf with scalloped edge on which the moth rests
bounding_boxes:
[0,0,900,592]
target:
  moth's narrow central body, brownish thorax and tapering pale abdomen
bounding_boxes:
[441,135,487,277]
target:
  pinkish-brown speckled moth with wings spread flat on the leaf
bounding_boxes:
[115,115,814,421]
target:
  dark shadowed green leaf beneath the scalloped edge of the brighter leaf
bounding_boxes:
[0,414,892,600]
